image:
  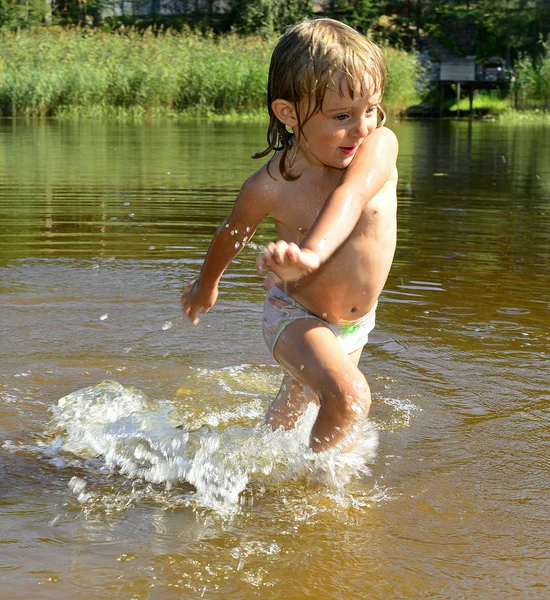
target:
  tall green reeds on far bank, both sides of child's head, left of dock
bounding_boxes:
[0,28,421,118]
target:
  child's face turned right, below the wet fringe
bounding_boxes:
[295,75,381,169]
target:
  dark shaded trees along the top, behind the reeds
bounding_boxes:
[0,0,550,71]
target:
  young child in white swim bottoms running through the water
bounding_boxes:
[182,19,397,451]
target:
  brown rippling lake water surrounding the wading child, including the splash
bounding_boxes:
[0,121,550,600]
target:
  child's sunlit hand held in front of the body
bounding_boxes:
[256,240,321,290]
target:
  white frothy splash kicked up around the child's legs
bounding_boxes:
[42,381,378,513]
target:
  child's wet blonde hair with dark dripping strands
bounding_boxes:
[252,19,387,181]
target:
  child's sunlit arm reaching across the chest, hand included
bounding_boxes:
[258,127,398,289]
